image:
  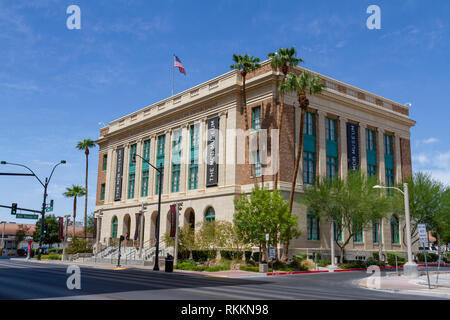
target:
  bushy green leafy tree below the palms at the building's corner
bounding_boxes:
[233,185,300,258]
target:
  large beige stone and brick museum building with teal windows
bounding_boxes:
[95,61,415,255]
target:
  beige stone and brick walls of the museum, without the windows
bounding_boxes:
[95,61,415,260]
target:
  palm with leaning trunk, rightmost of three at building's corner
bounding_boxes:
[278,71,325,260]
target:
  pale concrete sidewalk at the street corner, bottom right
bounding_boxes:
[358,271,450,299]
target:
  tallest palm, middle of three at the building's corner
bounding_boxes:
[268,47,303,190]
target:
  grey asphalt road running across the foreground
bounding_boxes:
[0,259,444,300]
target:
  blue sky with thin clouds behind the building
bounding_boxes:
[0,0,450,223]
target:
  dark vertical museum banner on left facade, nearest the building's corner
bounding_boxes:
[206,117,219,187]
